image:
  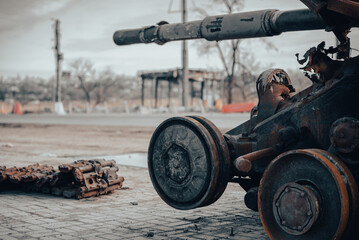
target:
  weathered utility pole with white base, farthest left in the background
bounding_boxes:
[54,19,66,115]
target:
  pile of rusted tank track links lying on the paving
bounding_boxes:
[0,159,124,199]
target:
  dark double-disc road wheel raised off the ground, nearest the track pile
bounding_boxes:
[148,117,231,210]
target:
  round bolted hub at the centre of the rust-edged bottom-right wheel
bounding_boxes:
[273,182,319,235]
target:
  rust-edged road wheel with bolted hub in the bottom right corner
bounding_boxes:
[258,149,358,240]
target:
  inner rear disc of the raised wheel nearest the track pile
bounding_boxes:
[189,116,232,205]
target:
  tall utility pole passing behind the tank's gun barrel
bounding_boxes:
[181,0,189,110]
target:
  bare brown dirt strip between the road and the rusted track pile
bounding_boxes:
[0,123,155,167]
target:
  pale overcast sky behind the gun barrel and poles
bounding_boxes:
[0,0,359,78]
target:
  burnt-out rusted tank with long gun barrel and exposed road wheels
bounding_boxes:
[114,0,359,240]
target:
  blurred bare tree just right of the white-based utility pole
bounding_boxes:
[70,58,99,103]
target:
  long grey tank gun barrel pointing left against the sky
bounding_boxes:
[113,9,326,45]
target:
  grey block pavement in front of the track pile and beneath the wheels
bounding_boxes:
[0,166,268,240]
